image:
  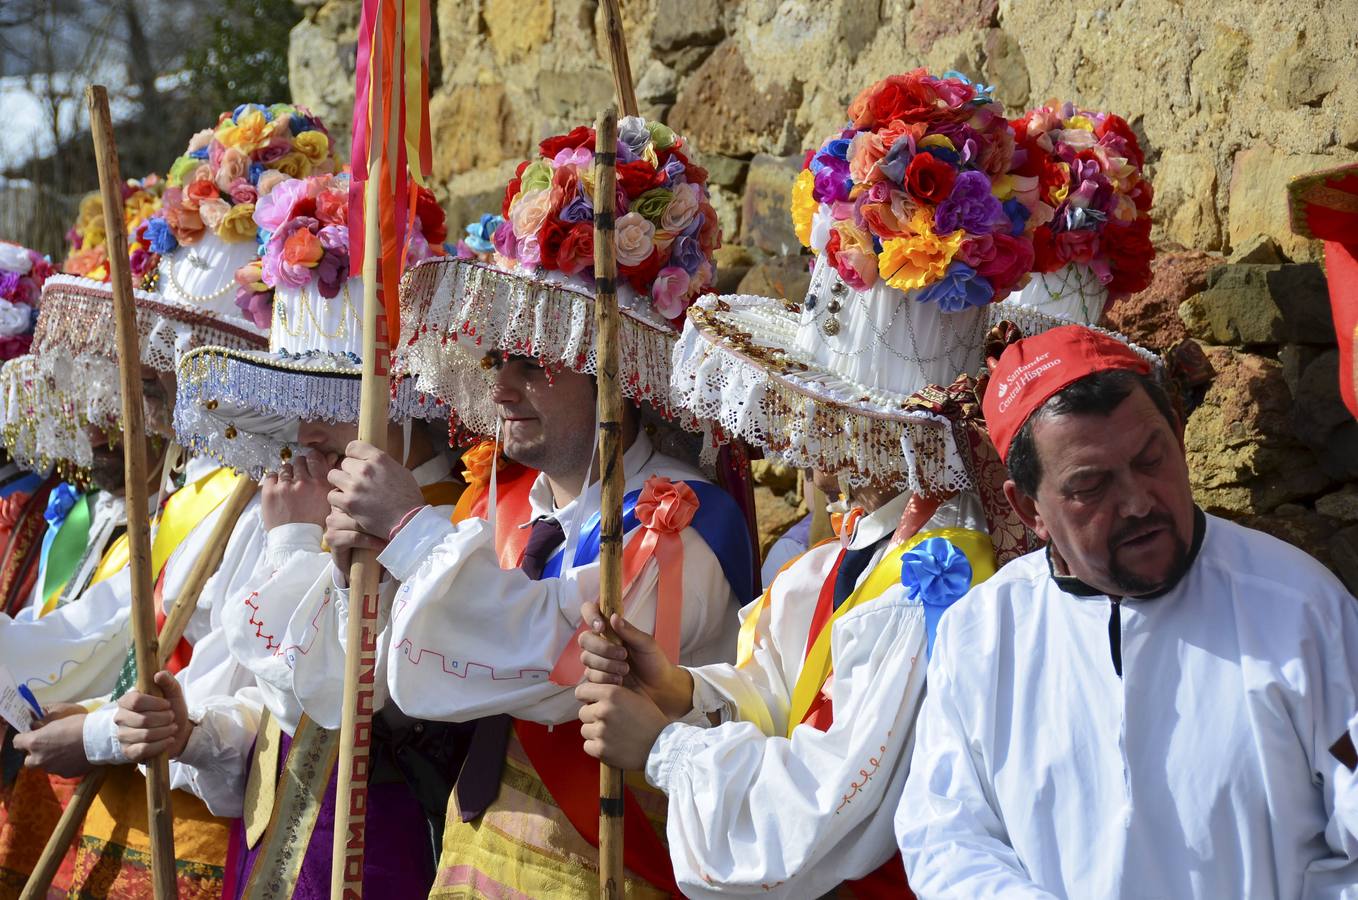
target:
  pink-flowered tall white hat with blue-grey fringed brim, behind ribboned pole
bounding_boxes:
[174,174,447,478]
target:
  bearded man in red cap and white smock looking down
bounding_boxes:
[895,326,1358,899]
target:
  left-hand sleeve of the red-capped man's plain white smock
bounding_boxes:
[895,616,1054,900]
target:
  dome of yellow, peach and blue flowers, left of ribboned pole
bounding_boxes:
[149,103,340,254]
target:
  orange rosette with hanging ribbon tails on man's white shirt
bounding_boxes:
[550,475,698,687]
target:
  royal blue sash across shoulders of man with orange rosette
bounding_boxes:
[542,482,755,605]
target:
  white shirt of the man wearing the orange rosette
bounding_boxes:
[379,508,736,725]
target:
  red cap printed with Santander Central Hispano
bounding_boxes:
[980,324,1150,463]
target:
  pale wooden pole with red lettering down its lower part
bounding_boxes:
[330,21,406,900]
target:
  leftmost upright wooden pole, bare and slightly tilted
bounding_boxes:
[86,84,179,900]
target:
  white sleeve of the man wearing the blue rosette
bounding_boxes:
[646,589,925,897]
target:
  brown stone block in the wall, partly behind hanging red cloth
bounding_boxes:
[1179,263,1335,345]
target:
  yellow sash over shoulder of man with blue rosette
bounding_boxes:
[788,528,995,737]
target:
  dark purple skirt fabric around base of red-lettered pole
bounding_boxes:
[223,734,435,900]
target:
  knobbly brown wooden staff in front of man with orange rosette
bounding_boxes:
[593,107,626,900]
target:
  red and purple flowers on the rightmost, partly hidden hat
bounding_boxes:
[1012,100,1156,300]
